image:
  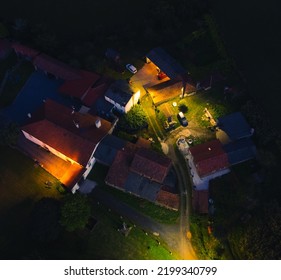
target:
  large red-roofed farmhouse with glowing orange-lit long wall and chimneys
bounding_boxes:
[21,100,112,190]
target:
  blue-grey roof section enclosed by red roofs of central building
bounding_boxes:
[125,172,161,202]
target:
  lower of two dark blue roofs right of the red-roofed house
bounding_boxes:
[223,138,256,165]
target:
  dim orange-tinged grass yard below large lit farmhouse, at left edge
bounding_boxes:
[0,146,62,258]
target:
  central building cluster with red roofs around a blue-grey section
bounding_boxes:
[105,145,179,210]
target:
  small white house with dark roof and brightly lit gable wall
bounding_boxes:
[105,80,140,113]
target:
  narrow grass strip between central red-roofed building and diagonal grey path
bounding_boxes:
[88,163,179,224]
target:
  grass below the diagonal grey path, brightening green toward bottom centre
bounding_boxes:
[41,202,173,260]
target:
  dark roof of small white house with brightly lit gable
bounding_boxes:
[105,80,135,106]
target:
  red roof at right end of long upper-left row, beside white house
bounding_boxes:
[59,70,100,100]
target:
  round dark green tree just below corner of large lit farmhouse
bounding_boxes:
[60,193,91,231]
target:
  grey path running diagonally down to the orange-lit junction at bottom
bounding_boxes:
[94,188,196,259]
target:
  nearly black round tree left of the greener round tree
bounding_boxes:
[29,197,61,242]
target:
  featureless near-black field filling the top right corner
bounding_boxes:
[212,0,281,132]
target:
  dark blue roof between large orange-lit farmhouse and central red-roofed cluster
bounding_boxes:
[94,134,126,165]
